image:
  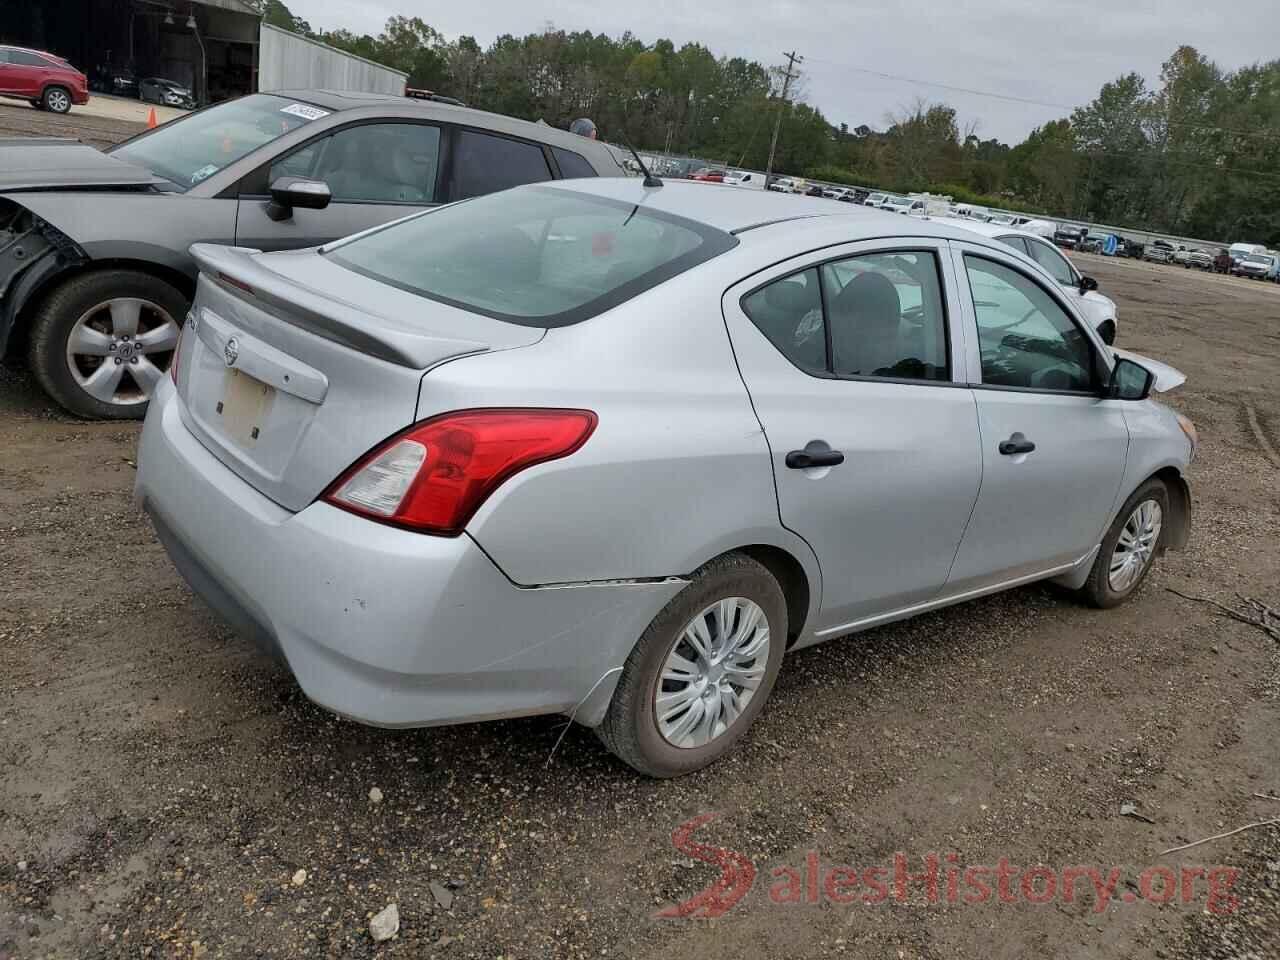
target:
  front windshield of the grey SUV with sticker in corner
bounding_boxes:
[110,93,329,191]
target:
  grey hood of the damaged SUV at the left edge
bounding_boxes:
[0,137,165,193]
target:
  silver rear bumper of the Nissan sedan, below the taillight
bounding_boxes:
[136,380,681,727]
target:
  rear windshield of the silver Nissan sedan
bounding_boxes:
[323,187,737,326]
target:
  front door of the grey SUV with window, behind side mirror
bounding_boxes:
[236,120,442,250]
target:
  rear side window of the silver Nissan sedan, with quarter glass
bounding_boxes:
[742,251,951,380]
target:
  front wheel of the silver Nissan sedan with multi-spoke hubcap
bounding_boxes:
[1080,477,1169,609]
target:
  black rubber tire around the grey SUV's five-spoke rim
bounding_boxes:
[28,270,187,420]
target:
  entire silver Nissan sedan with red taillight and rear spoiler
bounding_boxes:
[137,178,1196,777]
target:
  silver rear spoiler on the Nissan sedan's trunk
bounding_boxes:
[191,243,490,370]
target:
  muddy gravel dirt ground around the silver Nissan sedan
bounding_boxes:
[0,108,1280,960]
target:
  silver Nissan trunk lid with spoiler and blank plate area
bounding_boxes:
[178,243,545,511]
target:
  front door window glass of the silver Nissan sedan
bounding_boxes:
[964,255,1093,392]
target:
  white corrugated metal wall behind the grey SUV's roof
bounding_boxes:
[257,23,408,95]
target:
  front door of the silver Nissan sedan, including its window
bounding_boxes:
[947,243,1129,593]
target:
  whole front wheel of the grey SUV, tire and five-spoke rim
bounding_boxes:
[29,270,187,420]
